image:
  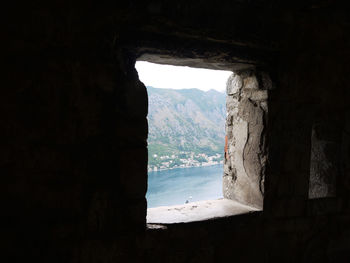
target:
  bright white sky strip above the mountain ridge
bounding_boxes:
[136,61,232,92]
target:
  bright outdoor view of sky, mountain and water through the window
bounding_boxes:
[136,61,232,208]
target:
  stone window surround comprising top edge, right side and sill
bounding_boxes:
[137,54,272,224]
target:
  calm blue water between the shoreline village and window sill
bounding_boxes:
[146,164,223,208]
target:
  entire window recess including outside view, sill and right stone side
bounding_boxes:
[136,60,266,223]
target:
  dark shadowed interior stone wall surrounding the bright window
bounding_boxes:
[0,0,350,262]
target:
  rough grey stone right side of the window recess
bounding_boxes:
[223,70,271,208]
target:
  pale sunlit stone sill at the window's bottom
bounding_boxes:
[147,199,261,224]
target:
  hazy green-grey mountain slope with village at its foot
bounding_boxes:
[147,86,226,171]
